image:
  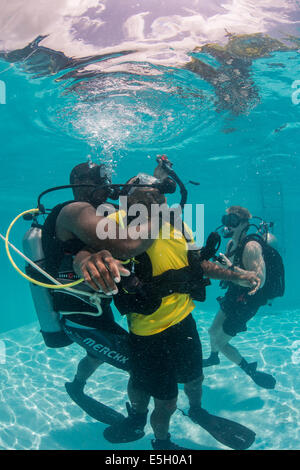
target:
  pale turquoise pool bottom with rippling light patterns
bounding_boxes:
[0,310,300,450]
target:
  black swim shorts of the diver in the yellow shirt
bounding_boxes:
[129,314,202,400]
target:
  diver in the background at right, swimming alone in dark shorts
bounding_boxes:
[203,206,283,389]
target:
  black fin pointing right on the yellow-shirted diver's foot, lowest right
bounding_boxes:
[188,408,255,450]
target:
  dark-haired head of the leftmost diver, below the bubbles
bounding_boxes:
[70,162,111,207]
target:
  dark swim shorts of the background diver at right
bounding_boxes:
[217,285,267,336]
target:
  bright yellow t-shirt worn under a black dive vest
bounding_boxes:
[110,213,195,336]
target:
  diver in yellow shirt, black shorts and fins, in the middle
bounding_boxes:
[67,156,260,450]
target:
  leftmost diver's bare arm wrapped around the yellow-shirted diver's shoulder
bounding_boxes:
[56,202,154,259]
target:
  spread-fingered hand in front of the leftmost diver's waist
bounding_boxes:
[75,250,130,295]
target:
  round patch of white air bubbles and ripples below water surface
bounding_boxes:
[57,63,213,165]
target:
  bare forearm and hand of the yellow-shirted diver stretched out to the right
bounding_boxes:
[201,260,261,295]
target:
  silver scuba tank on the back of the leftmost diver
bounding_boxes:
[23,225,73,348]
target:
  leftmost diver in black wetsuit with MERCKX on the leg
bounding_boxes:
[23,158,176,424]
